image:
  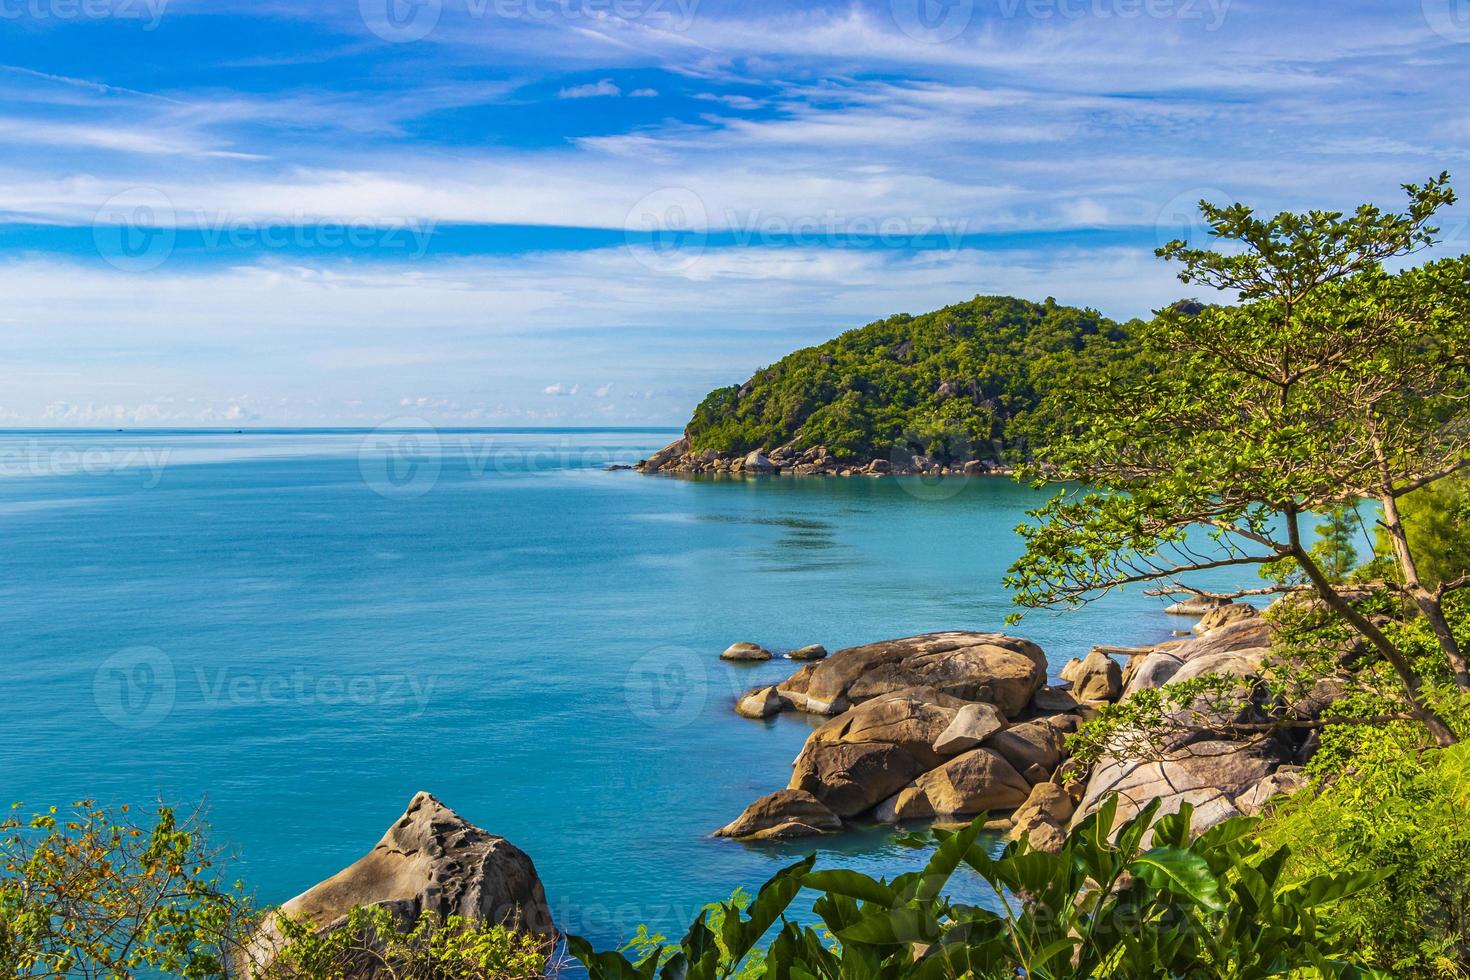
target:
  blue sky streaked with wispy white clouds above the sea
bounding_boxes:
[0,0,1470,428]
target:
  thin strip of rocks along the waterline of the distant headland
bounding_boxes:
[634,438,1013,476]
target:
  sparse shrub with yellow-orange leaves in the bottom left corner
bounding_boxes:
[0,801,245,977]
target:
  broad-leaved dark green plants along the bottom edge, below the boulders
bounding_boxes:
[567,799,1380,980]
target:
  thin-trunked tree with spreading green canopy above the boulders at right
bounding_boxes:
[1008,175,1470,745]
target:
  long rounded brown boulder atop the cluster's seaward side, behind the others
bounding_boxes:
[782,632,1047,717]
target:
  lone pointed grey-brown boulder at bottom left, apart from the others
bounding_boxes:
[245,793,556,970]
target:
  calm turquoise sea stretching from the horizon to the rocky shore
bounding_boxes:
[0,430,1250,945]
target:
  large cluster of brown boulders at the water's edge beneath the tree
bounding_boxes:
[716,602,1301,849]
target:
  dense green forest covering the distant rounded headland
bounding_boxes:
[686,297,1138,461]
